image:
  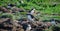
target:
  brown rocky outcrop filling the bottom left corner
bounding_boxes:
[0,18,23,31]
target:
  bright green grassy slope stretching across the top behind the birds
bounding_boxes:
[0,0,60,19]
